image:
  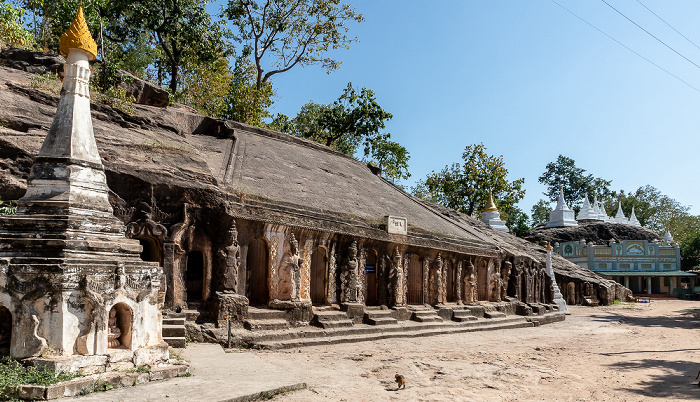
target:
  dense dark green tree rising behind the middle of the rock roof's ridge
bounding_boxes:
[269,83,410,180]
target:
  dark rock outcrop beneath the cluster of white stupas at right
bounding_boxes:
[525,222,661,244]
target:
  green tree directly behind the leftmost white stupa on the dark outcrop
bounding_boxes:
[538,155,611,212]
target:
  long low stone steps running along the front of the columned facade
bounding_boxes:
[246,316,565,349]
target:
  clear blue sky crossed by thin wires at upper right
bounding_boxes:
[219,0,700,214]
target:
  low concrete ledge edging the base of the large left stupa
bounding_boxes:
[9,365,189,400]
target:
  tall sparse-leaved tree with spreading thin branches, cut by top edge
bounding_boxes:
[224,0,363,91]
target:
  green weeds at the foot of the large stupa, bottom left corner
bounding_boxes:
[0,358,81,399]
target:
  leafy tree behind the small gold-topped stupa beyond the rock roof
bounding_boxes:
[413,144,525,216]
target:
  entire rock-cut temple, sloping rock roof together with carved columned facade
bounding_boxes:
[0,55,628,336]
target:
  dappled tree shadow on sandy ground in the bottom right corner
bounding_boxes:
[609,359,700,400]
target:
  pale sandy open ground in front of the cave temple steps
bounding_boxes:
[254,300,700,401]
